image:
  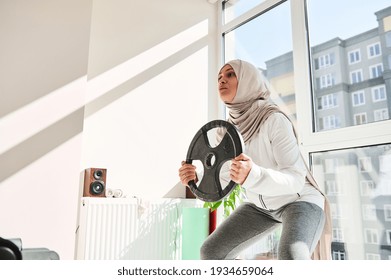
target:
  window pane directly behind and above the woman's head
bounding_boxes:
[224,1,298,121]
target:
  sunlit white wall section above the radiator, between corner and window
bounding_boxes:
[83,0,217,199]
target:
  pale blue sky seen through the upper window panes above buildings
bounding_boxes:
[226,0,391,68]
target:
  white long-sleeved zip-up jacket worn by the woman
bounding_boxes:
[224,113,324,210]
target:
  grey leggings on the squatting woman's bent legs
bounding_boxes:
[201,201,325,260]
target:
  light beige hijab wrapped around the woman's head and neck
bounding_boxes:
[222,59,283,143]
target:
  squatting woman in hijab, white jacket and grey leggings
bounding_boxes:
[179,60,330,260]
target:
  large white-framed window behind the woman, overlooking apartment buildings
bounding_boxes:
[220,0,391,260]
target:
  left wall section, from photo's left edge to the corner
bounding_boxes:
[0,0,92,259]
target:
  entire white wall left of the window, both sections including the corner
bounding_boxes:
[0,0,217,259]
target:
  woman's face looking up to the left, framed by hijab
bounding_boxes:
[218,64,238,103]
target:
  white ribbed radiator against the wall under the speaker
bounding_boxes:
[76,197,202,260]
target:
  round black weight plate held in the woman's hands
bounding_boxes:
[186,120,243,202]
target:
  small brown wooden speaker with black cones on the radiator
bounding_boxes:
[83,168,107,197]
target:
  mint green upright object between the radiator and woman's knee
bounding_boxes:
[182,208,209,260]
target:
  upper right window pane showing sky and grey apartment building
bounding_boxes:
[307,0,391,131]
